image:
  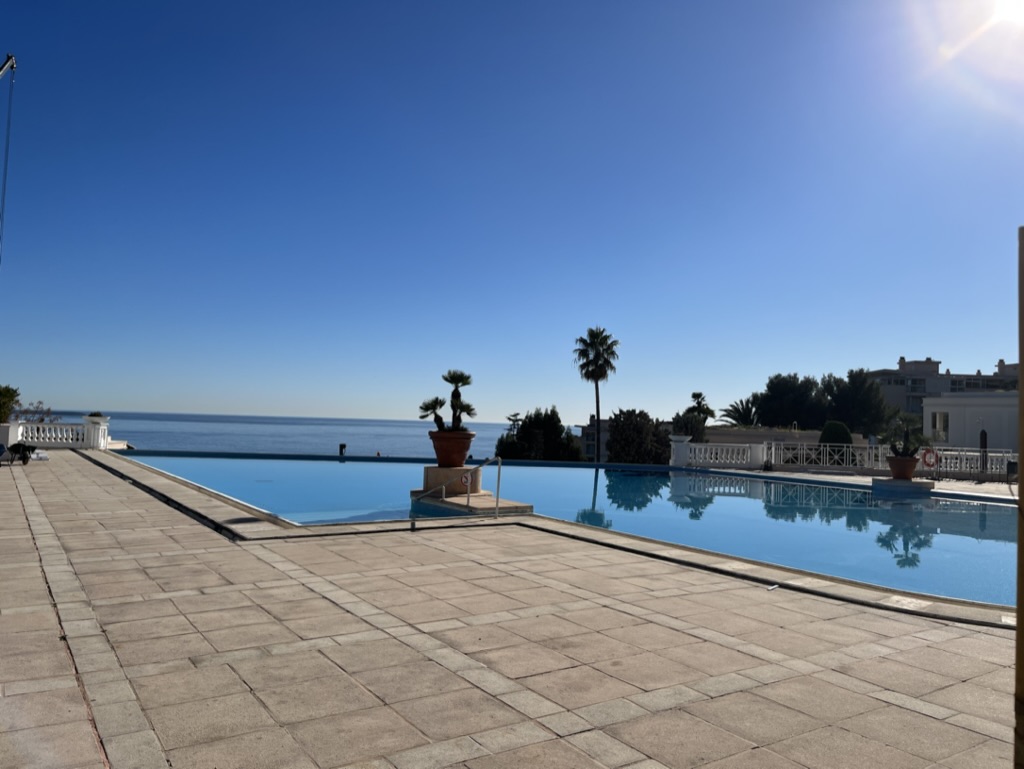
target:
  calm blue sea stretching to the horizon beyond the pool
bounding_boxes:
[54,411,508,459]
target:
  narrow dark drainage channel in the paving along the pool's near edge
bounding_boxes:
[73,448,1016,630]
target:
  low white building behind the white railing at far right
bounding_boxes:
[923,391,1020,452]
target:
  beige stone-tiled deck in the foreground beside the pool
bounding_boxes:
[0,451,1015,769]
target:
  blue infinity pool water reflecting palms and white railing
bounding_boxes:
[131,454,1017,605]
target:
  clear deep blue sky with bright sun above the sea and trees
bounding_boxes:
[0,0,1024,423]
